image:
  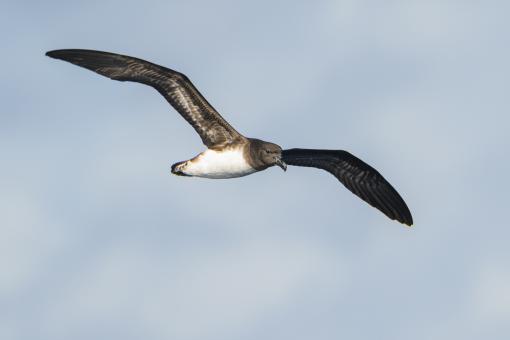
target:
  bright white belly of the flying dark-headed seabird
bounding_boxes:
[183,149,256,178]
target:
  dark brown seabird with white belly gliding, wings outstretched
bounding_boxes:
[46,49,413,226]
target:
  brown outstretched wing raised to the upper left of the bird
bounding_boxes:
[46,49,243,148]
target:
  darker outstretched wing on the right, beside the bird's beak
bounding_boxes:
[282,149,413,226]
